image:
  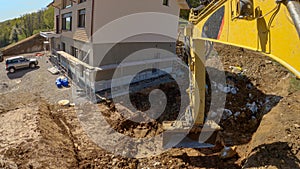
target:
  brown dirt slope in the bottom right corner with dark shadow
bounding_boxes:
[240,92,300,168]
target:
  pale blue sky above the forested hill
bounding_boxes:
[0,0,52,22]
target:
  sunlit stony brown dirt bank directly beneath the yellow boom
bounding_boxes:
[215,44,289,96]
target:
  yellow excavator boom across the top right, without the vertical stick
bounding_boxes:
[190,0,300,78]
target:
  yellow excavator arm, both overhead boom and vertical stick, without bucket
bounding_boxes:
[186,0,300,125]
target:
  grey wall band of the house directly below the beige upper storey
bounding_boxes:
[54,35,176,67]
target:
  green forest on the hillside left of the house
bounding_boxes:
[0,7,54,48]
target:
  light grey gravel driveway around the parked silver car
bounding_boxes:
[0,54,72,103]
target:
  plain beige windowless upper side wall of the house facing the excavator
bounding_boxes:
[93,0,180,43]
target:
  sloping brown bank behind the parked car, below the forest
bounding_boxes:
[2,34,45,56]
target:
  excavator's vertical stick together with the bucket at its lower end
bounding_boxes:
[163,36,220,148]
